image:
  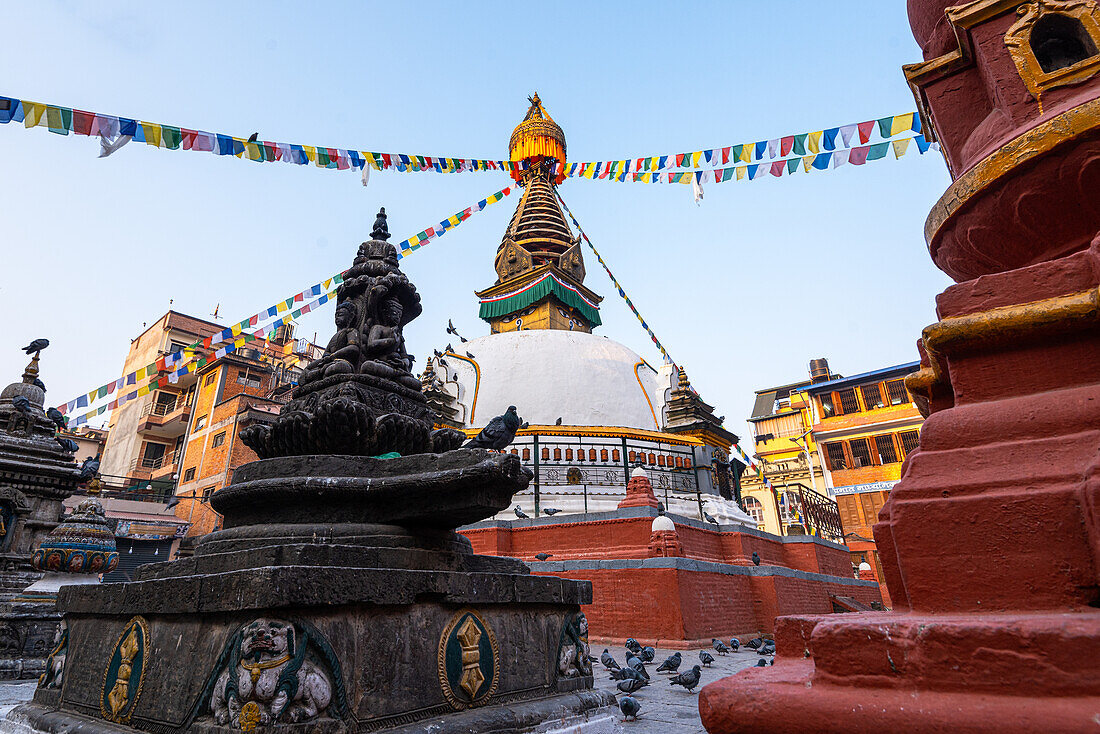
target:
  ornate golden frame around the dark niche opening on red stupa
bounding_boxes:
[1004,0,1100,114]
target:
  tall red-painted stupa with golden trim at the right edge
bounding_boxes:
[700,0,1100,734]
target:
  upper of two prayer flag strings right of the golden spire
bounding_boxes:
[568,112,923,180]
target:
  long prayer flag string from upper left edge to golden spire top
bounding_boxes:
[0,96,514,180]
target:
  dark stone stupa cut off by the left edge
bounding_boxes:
[0,347,80,678]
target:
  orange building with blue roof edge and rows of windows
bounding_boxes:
[803,362,924,604]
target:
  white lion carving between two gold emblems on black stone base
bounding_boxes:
[204,618,348,731]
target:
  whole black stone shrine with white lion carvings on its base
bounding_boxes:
[6,211,612,734]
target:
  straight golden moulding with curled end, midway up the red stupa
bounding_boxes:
[905,287,1100,397]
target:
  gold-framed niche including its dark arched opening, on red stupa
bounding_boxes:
[1004,0,1100,100]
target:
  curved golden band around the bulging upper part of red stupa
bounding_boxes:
[924,93,1100,245]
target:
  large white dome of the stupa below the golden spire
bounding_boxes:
[448,329,664,430]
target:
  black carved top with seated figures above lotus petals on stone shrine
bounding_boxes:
[241,209,464,459]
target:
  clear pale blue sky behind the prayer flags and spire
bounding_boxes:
[0,0,949,442]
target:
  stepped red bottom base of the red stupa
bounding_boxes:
[700,611,1100,734]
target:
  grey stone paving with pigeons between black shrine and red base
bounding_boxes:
[592,645,772,734]
